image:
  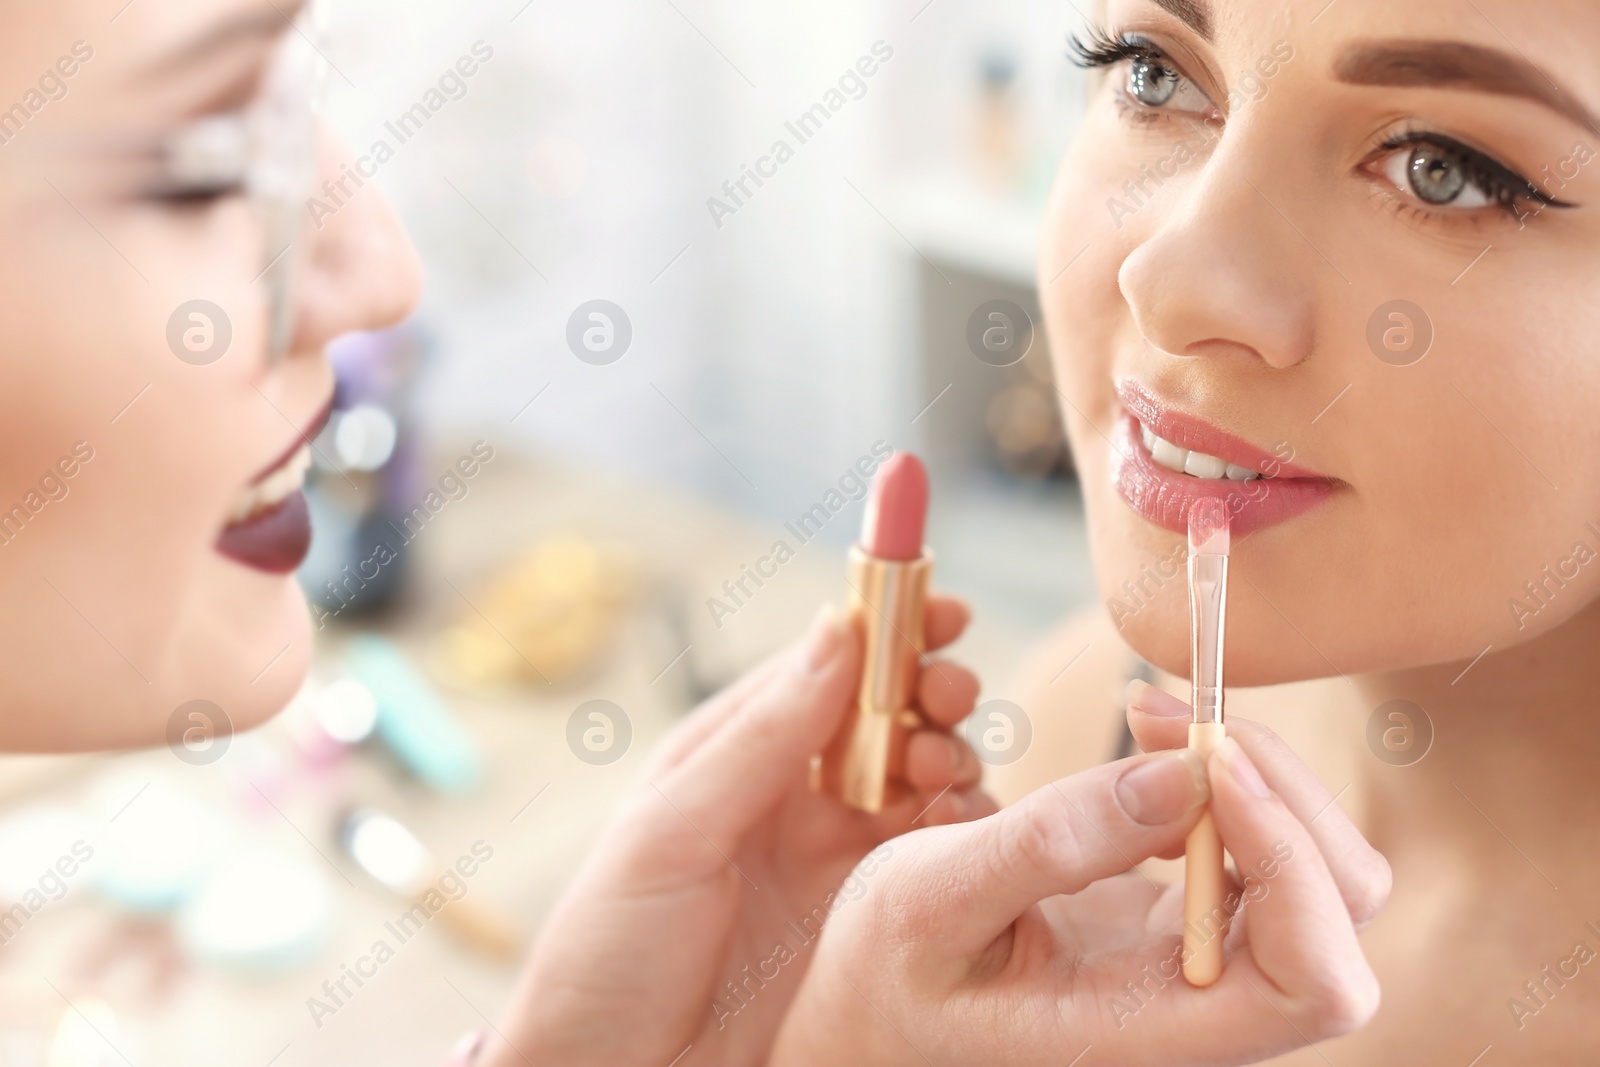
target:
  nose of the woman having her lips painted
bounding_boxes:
[1117,132,1339,368]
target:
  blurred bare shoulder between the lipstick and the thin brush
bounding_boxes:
[984,606,1177,803]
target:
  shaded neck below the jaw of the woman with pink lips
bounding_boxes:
[1357,605,1600,888]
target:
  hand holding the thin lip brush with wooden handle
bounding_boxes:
[770,683,1389,1067]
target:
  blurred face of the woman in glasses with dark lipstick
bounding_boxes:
[0,0,419,749]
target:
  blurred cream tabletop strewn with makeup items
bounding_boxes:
[0,453,1037,1067]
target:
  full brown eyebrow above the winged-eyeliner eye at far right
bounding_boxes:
[1333,40,1600,133]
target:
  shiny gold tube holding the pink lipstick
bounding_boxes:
[811,545,933,811]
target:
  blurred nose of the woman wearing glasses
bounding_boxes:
[290,126,422,354]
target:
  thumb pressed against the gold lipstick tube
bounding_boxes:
[654,608,861,849]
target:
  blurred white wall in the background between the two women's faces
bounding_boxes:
[315,0,1080,531]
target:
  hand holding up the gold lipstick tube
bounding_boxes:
[478,597,995,1067]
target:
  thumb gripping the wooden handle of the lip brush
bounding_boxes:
[898,749,1210,958]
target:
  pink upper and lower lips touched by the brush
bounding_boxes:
[1110,379,1336,536]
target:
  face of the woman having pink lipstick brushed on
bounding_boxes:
[1038,0,1600,685]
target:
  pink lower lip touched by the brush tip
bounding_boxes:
[1112,413,1333,537]
